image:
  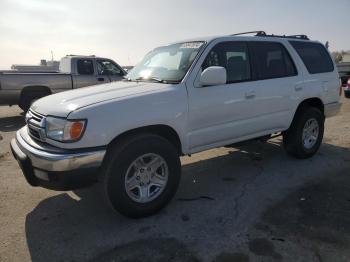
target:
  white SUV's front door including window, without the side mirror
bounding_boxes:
[188,41,257,152]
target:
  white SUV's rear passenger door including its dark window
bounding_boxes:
[249,41,302,134]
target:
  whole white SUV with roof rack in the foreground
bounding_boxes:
[11,32,341,217]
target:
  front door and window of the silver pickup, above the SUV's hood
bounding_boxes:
[96,59,125,82]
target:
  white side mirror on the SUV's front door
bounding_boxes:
[199,66,227,87]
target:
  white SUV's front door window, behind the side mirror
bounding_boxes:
[202,42,251,83]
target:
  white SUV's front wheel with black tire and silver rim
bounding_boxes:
[101,134,181,218]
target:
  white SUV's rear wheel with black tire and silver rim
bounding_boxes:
[283,106,325,159]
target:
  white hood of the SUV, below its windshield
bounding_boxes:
[31,81,169,117]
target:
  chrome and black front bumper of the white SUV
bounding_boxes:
[11,127,106,190]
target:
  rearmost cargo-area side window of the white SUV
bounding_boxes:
[289,41,334,74]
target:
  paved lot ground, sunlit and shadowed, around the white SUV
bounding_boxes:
[0,99,350,262]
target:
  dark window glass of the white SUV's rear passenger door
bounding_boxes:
[252,42,297,79]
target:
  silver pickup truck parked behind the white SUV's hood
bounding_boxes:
[0,55,126,111]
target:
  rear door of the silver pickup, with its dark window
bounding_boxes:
[73,58,99,88]
